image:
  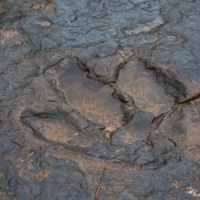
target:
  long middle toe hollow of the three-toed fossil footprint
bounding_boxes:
[46,57,124,131]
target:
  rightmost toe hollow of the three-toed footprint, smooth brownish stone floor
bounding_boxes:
[117,61,173,116]
